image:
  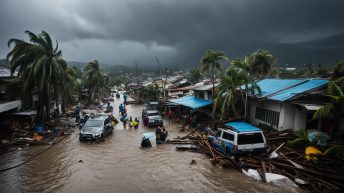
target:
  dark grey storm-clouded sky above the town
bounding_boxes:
[0,0,344,68]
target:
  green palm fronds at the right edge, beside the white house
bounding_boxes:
[313,82,344,135]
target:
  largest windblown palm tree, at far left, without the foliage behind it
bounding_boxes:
[7,31,62,121]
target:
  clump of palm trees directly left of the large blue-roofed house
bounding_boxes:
[213,50,276,118]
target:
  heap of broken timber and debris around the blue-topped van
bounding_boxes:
[167,130,344,192]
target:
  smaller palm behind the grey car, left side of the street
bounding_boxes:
[84,60,103,103]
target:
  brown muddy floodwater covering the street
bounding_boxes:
[0,101,301,193]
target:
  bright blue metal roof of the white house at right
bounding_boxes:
[245,79,328,101]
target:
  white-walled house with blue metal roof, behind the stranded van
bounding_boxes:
[249,79,328,131]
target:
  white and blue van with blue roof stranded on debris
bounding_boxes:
[208,122,267,155]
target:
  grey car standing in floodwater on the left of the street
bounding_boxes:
[79,116,113,141]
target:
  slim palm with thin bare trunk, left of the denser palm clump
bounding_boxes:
[200,50,229,99]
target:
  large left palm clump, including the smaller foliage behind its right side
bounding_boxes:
[7,31,75,122]
